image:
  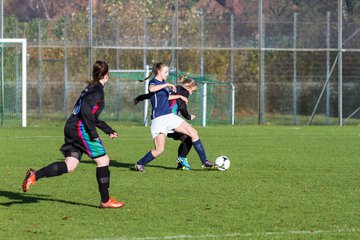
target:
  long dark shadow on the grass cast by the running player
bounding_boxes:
[0,190,98,208]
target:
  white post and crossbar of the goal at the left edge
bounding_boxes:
[0,38,27,127]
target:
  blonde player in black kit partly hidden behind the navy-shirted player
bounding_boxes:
[134,75,198,170]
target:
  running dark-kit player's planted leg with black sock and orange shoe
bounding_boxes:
[93,154,125,208]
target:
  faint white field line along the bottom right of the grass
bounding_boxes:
[91,229,360,240]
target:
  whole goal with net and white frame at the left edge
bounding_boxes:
[0,38,27,127]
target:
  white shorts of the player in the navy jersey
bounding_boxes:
[150,113,184,138]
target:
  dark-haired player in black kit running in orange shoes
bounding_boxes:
[22,61,124,208]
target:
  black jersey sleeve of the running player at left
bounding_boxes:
[81,94,99,140]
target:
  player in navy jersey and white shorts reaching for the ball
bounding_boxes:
[135,63,214,172]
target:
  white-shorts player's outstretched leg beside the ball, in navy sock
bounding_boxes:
[175,121,214,168]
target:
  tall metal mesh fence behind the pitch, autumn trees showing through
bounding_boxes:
[1,0,360,125]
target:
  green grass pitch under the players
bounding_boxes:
[0,125,360,239]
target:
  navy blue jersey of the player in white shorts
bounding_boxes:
[149,78,171,119]
